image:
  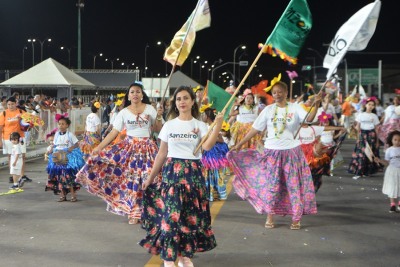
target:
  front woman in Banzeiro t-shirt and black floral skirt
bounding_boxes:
[139,86,223,266]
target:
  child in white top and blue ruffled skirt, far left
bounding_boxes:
[47,114,85,202]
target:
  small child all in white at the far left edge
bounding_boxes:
[10,132,24,192]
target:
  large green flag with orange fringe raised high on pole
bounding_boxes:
[263,0,312,64]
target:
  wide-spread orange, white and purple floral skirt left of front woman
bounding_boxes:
[76,136,159,219]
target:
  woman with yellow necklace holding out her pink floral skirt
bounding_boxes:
[228,82,321,230]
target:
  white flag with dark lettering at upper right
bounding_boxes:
[324,0,381,79]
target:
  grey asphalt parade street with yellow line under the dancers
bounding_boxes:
[0,140,400,267]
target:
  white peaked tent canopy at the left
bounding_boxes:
[0,58,96,88]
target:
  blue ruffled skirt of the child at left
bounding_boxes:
[46,148,85,193]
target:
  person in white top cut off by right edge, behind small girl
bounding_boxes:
[378,96,400,144]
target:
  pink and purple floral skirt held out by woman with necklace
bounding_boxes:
[228,146,317,221]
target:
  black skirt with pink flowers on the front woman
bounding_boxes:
[139,158,217,261]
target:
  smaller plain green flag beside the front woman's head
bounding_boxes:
[204,81,235,120]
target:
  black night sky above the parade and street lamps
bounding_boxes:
[0,0,400,86]
